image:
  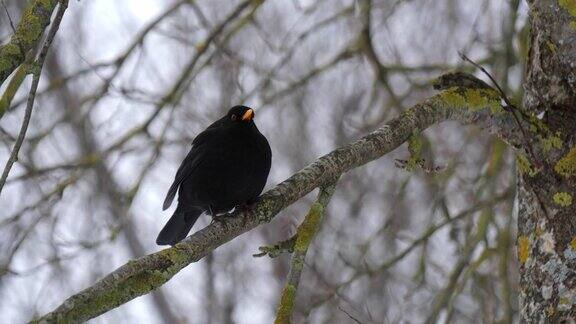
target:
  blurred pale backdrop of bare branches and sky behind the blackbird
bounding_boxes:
[0,0,527,323]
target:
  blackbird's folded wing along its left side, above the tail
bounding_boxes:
[162,124,217,210]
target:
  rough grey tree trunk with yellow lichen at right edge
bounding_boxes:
[517,0,576,322]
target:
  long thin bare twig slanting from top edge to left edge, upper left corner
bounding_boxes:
[0,0,68,194]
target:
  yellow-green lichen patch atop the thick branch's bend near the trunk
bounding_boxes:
[439,87,504,113]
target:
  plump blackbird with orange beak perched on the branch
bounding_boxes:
[156,106,272,245]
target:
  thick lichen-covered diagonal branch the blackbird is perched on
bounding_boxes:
[35,73,519,323]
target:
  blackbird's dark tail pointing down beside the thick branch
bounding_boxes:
[156,205,202,245]
